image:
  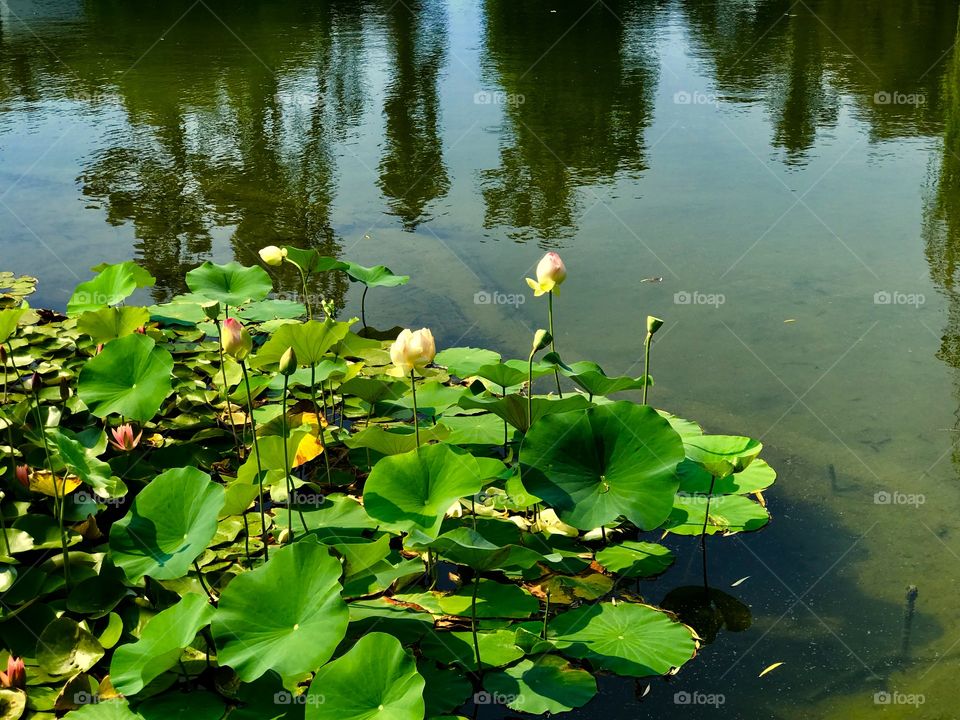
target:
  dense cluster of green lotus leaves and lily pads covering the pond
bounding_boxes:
[0,258,776,720]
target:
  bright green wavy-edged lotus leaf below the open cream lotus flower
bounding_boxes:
[363,445,486,537]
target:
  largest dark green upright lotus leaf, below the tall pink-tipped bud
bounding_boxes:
[520,402,683,530]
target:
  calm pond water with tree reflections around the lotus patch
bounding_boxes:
[0,0,960,718]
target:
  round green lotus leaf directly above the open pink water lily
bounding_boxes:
[77,335,173,422]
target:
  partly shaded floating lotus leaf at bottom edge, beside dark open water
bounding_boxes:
[483,655,597,715]
